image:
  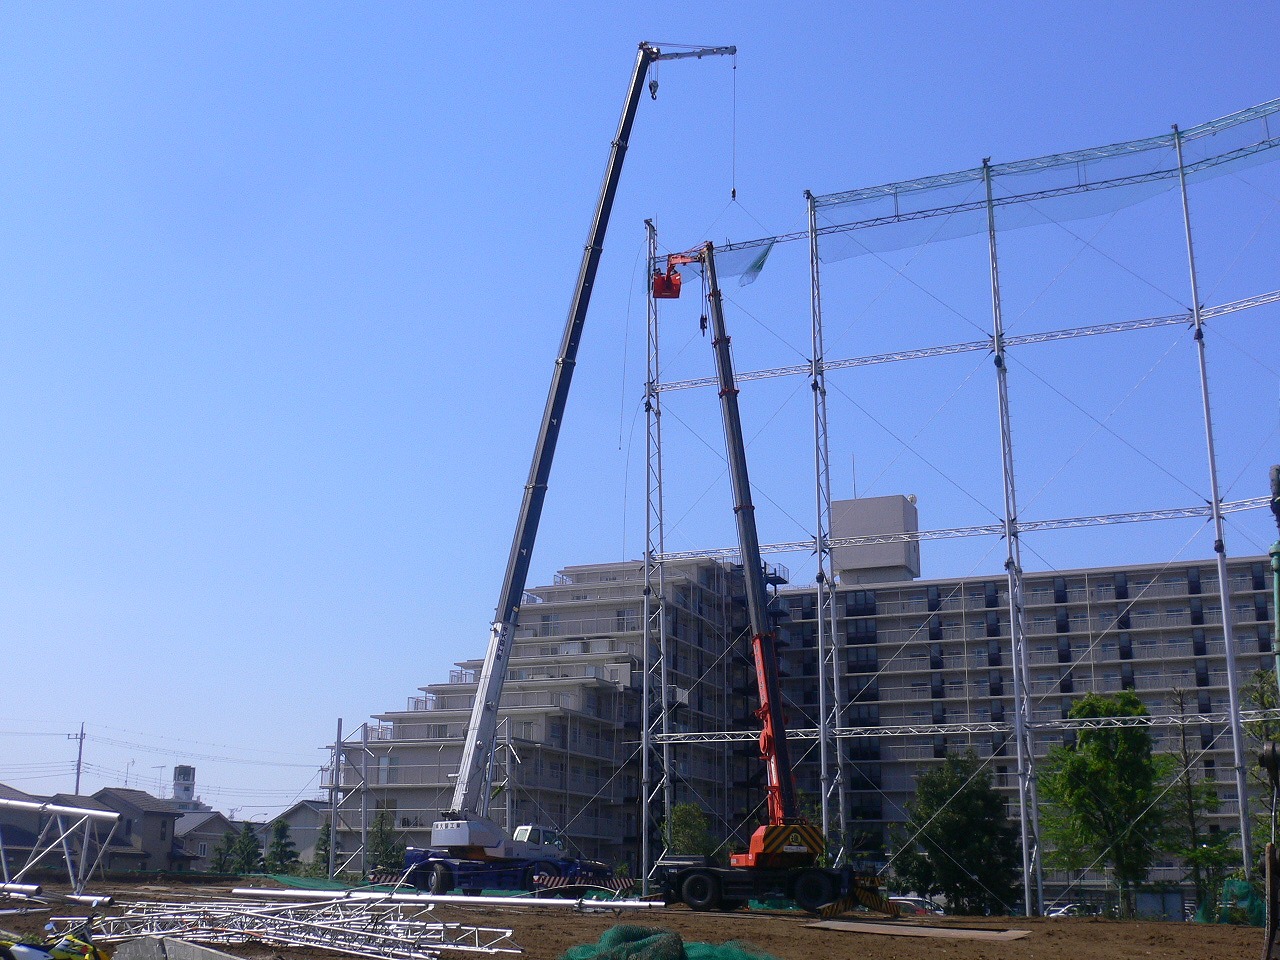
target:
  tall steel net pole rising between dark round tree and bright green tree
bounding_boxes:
[982,159,1044,916]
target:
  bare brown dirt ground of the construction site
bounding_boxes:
[0,881,1262,960]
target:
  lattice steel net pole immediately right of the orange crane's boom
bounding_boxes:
[805,191,850,865]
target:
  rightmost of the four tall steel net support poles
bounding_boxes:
[1174,124,1253,877]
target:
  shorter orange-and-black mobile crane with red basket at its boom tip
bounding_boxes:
[653,243,896,914]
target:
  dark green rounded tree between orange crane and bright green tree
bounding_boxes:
[893,751,1020,914]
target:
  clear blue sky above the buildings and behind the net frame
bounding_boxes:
[0,0,1280,817]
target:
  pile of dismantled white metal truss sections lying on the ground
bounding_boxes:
[70,900,522,960]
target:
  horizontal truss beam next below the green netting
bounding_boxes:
[654,291,1280,393]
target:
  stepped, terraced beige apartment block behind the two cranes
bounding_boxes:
[338,561,758,869]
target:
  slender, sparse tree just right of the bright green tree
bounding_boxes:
[1164,690,1236,905]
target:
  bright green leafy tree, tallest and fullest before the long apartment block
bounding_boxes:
[1039,690,1169,915]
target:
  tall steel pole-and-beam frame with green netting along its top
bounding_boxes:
[645,100,1280,914]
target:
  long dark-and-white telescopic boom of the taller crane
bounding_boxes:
[431,44,737,850]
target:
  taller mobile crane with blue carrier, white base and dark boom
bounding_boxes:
[406,42,737,892]
